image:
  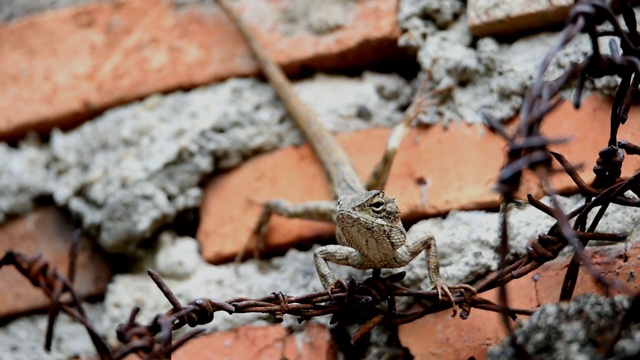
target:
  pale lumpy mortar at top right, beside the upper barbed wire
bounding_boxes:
[399,1,617,124]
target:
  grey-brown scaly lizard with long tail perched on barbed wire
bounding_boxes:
[216,0,476,316]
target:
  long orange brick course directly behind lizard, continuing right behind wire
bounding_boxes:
[196,95,640,263]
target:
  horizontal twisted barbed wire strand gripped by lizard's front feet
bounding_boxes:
[109,270,532,359]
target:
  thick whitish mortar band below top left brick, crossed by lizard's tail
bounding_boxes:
[0,73,411,252]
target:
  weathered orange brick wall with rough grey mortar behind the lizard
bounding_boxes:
[0,0,640,358]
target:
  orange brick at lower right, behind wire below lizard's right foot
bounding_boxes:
[398,243,640,359]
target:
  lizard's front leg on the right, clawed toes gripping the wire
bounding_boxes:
[389,232,477,316]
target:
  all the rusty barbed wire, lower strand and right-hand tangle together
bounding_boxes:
[0,0,640,360]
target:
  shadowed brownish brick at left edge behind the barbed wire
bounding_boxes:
[0,207,111,318]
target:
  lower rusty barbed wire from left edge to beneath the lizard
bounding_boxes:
[0,242,520,360]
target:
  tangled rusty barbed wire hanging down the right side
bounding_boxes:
[478,0,640,352]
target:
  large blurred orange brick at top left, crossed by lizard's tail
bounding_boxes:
[0,0,399,140]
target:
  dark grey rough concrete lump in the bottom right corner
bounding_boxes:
[487,294,640,359]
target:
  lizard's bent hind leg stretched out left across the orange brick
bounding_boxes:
[236,199,336,263]
